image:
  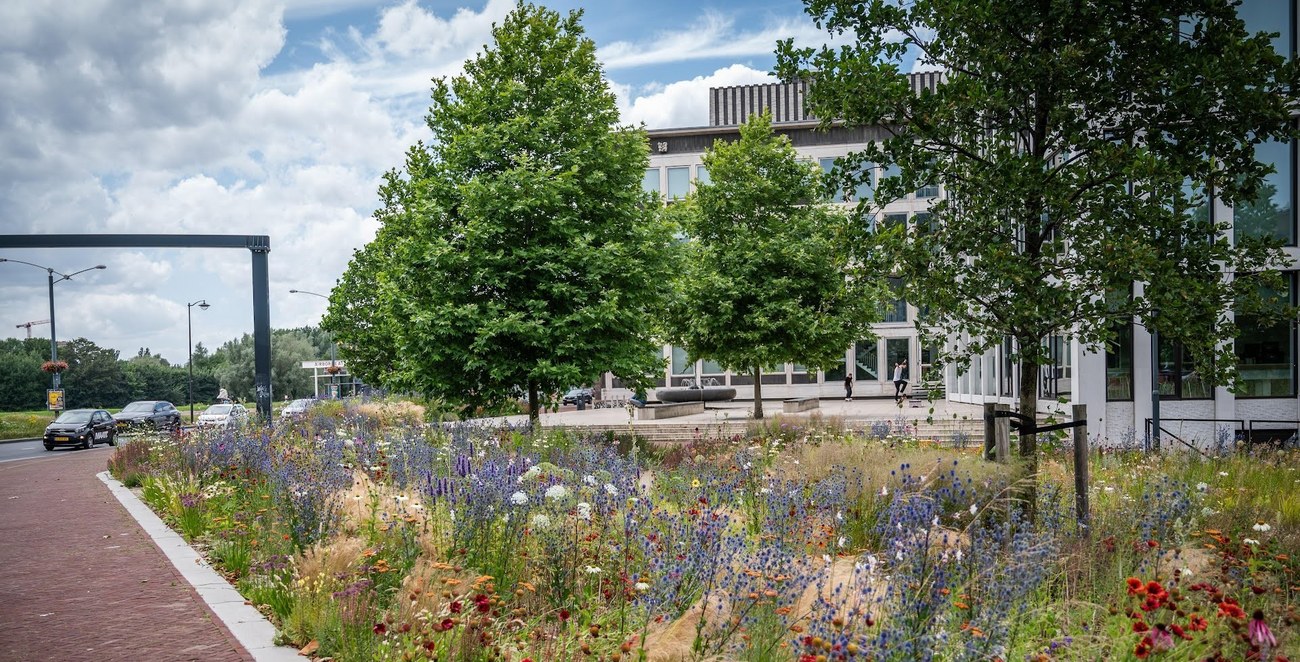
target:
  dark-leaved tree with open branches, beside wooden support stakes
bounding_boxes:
[779,0,1297,473]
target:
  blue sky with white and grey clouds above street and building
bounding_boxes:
[0,0,873,364]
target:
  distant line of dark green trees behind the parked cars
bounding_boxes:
[0,326,333,411]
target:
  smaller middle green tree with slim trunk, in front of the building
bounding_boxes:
[671,113,879,419]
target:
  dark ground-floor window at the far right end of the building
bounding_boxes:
[1236,273,1296,398]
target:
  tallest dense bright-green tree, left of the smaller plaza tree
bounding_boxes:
[326,4,672,417]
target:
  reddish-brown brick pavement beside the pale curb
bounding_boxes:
[0,446,252,662]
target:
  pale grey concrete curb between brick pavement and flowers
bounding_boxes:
[98,471,304,662]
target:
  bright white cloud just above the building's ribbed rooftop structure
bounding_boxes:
[616,64,776,129]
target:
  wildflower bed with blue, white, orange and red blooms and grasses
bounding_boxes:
[111,407,1300,662]
